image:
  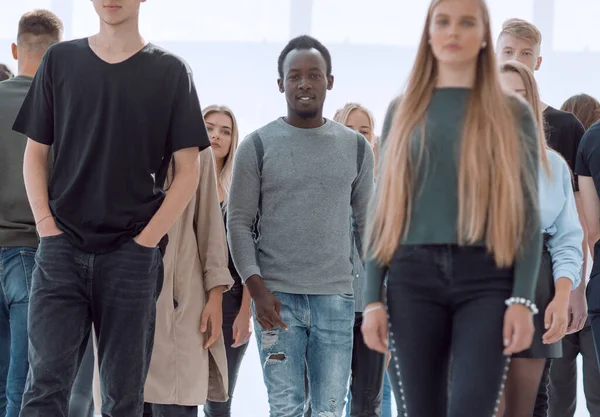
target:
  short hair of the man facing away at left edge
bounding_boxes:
[17,9,64,52]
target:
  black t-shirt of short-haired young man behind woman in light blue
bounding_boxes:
[544,106,585,191]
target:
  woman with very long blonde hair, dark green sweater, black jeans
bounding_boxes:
[363,0,542,417]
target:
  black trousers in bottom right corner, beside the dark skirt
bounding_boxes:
[548,325,600,417]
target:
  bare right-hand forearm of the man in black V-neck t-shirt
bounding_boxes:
[135,148,200,247]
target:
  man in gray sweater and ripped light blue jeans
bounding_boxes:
[228,36,373,417]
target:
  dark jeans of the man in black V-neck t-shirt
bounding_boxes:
[20,235,163,417]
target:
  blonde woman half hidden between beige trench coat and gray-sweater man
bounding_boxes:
[203,105,252,417]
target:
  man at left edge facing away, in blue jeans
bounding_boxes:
[0,10,63,417]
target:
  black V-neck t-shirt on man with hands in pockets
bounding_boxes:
[13,39,210,253]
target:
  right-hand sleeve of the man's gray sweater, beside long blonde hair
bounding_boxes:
[351,136,375,256]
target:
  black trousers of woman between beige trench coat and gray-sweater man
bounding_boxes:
[203,283,248,417]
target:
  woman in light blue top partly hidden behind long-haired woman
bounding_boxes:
[500,61,584,417]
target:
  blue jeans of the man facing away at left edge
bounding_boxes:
[0,247,35,417]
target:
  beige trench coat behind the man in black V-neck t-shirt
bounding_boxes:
[94,148,233,408]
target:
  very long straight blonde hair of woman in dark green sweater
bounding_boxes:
[368,0,537,266]
